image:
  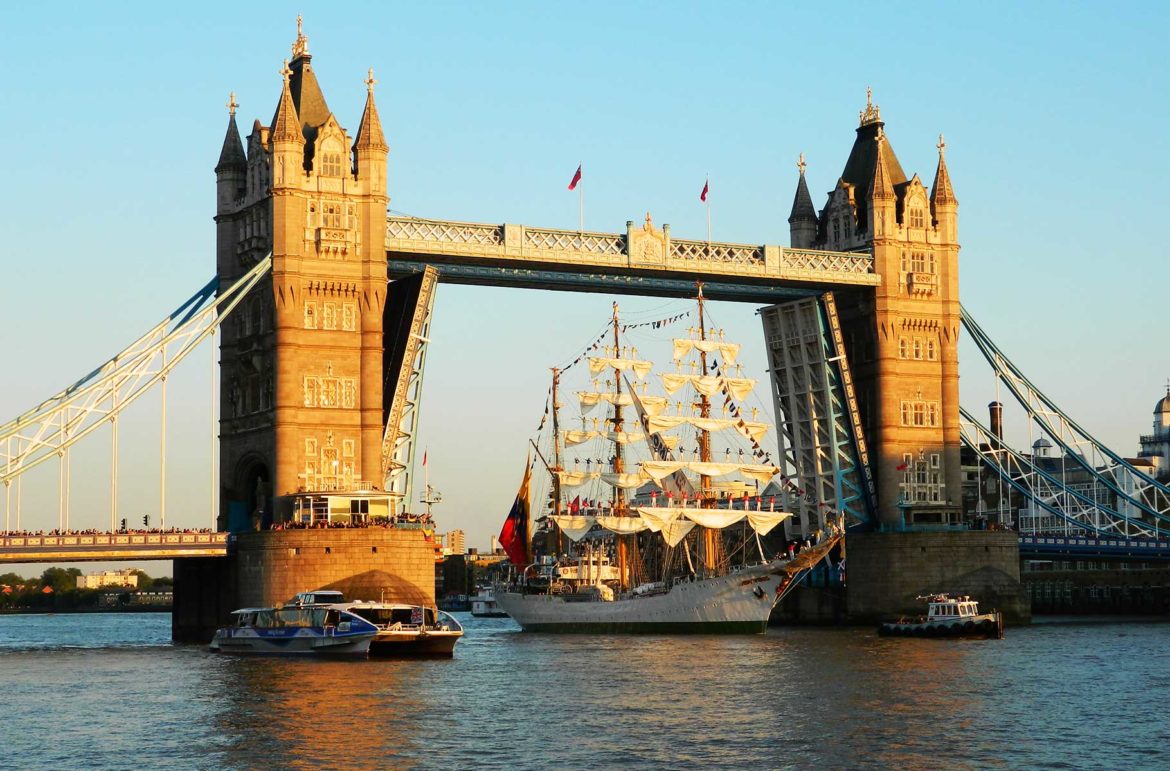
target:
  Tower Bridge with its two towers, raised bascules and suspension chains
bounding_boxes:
[27,23,1170,639]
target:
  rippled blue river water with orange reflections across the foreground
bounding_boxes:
[0,614,1170,769]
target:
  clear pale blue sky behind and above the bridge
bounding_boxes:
[0,2,1170,570]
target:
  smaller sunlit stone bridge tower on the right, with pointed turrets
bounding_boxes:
[789,91,962,528]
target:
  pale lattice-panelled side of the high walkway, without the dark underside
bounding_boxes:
[386,216,881,285]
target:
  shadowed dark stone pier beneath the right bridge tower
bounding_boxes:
[846,530,1032,624]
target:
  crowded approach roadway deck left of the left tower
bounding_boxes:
[0,530,230,564]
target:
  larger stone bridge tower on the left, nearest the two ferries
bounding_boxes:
[215,21,390,530]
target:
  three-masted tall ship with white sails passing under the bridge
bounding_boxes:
[495,284,844,633]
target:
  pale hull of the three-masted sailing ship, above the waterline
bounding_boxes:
[496,560,790,634]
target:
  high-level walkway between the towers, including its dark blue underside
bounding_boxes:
[386,214,881,303]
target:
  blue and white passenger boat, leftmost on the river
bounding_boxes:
[211,591,378,658]
